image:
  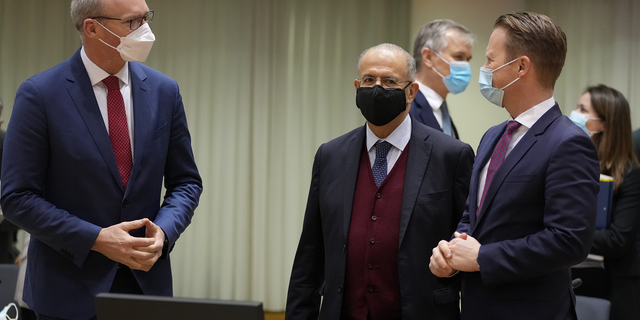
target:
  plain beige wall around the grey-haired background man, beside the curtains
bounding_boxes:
[407,0,525,150]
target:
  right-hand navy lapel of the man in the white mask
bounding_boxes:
[129,62,155,194]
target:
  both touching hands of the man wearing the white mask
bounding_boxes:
[91,218,164,271]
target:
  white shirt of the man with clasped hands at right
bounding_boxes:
[477,97,556,204]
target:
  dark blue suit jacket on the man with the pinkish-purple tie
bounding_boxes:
[458,104,600,320]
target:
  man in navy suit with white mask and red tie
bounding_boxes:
[2,0,202,319]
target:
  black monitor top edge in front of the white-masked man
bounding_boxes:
[96,293,264,320]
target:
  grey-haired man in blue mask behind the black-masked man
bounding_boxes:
[411,19,474,139]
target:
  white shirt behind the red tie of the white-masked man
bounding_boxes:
[80,47,133,159]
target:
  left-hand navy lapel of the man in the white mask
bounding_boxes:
[66,49,124,191]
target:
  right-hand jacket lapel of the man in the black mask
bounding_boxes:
[398,120,433,247]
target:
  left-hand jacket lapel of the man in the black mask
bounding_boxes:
[342,126,366,239]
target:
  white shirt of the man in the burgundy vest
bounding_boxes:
[367,115,411,174]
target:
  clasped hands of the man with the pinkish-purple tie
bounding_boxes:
[429,232,480,278]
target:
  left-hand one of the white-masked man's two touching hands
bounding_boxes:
[91,218,155,271]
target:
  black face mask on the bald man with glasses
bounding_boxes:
[356,83,411,126]
